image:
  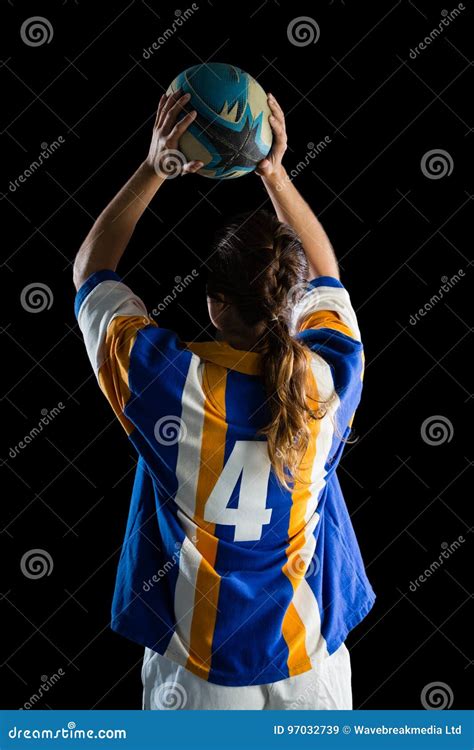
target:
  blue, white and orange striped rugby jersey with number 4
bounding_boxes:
[75,270,375,686]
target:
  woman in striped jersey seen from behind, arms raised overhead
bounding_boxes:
[74,92,375,709]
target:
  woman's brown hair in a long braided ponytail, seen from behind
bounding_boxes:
[206,211,326,487]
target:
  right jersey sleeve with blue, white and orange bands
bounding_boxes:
[293,276,364,437]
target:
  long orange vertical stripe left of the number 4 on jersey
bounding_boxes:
[186,362,227,679]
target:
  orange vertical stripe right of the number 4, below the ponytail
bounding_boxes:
[282,373,320,677]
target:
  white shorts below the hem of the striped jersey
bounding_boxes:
[142,643,352,711]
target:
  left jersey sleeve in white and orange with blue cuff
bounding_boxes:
[75,270,156,433]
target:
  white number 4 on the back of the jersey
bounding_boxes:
[204,440,272,542]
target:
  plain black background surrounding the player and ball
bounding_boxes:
[1,0,472,709]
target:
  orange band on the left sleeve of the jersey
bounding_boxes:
[98,315,156,435]
